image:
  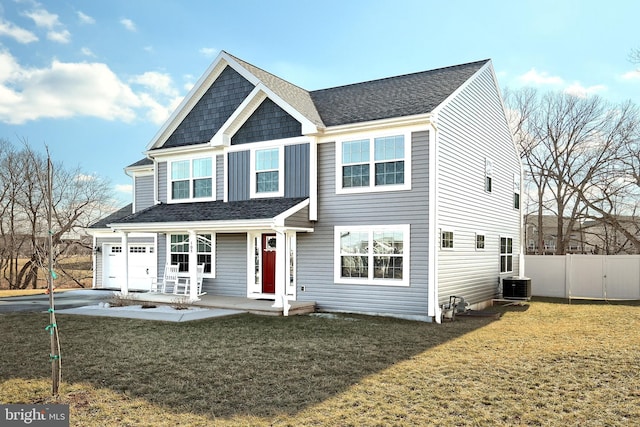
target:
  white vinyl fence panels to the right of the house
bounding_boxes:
[524,255,640,300]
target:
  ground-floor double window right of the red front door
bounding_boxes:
[335,225,409,286]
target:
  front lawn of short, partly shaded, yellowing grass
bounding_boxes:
[0,301,640,426]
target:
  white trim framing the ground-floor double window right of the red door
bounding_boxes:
[333,224,411,286]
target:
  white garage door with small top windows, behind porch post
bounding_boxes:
[102,244,156,290]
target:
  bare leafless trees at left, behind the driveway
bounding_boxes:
[0,141,112,288]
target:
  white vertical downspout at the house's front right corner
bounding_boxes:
[427,116,442,323]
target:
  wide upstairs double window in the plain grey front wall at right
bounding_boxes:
[336,135,411,193]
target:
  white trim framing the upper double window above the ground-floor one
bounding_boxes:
[335,131,412,194]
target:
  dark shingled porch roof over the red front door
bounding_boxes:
[110,198,306,224]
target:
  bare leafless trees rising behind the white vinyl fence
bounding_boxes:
[505,89,640,254]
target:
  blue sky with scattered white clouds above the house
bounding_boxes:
[0,0,640,204]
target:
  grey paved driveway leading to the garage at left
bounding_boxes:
[0,289,113,313]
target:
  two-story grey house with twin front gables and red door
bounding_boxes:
[90,52,521,320]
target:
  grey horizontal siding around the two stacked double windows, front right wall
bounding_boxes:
[297,129,429,318]
